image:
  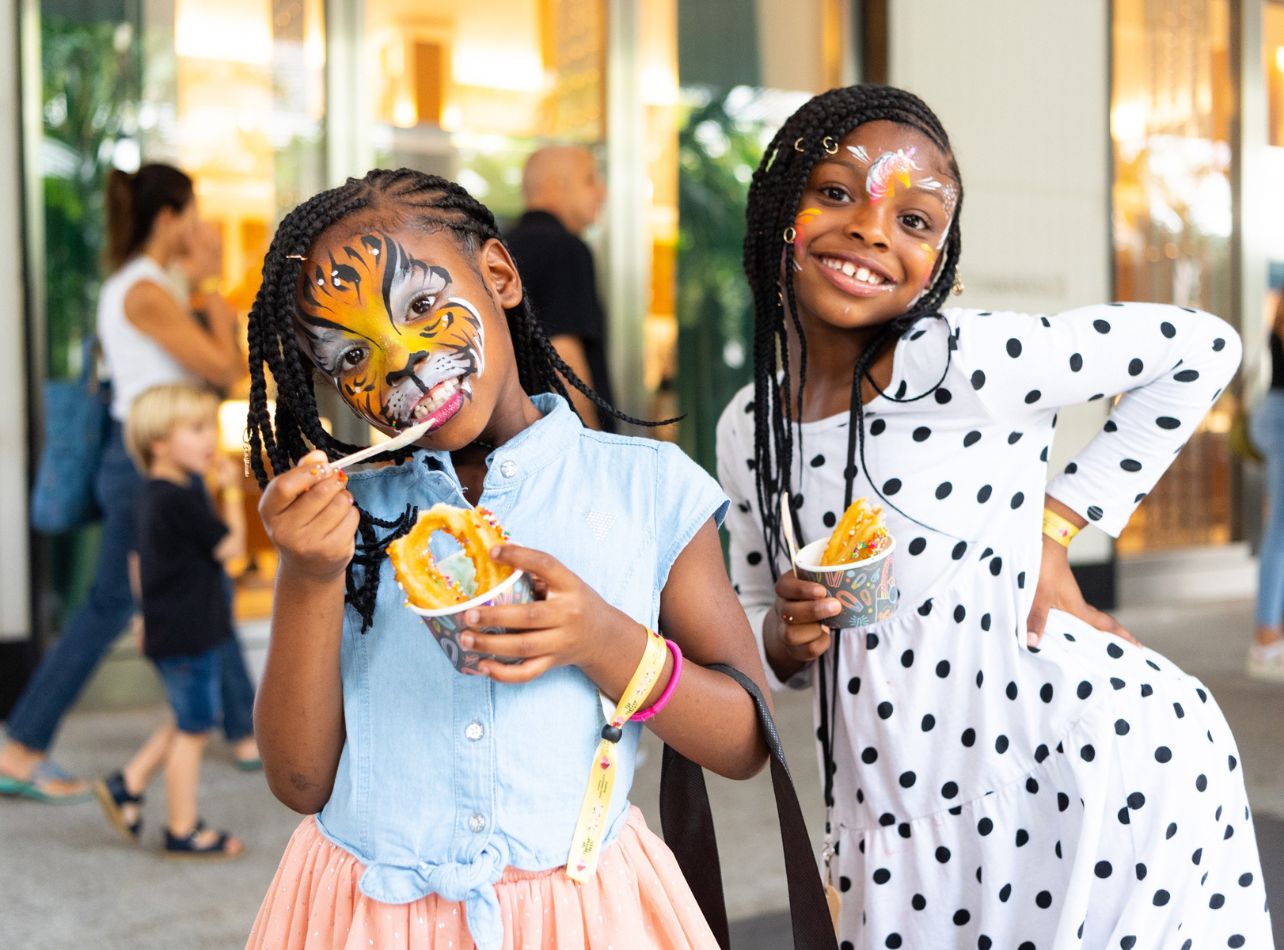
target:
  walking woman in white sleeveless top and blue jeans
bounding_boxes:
[0,164,252,802]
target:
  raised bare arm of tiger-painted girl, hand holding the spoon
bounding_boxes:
[254,452,360,814]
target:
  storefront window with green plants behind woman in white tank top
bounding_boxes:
[33,0,325,620]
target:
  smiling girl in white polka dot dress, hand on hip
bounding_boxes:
[718,86,1271,950]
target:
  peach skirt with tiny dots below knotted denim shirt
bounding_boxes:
[247,809,718,950]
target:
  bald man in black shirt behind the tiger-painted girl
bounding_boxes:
[507,145,614,431]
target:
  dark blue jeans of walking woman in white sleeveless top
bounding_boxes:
[8,421,254,752]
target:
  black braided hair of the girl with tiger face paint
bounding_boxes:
[247,168,672,633]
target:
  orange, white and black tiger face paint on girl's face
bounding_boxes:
[297,230,485,429]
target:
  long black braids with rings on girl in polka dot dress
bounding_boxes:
[743,85,963,575]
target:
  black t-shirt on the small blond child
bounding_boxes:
[139,479,232,660]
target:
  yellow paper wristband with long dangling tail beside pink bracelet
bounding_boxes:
[566,630,669,883]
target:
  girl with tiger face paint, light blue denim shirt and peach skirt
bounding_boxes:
[249,169,767,950]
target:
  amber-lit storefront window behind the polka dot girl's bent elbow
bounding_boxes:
[1111,0,1238,553]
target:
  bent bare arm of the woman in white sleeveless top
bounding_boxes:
[125,281,245,388]
